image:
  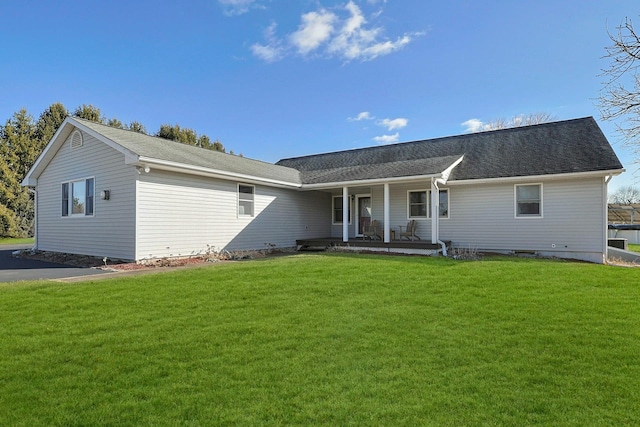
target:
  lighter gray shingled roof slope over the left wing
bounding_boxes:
[73,117,301,184]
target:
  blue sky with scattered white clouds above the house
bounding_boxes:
[0,0,640,190]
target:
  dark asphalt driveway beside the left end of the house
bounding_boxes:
[0,245,108,282]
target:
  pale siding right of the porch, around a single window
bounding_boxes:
[440,178,606,262]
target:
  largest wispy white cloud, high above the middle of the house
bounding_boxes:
[246,0,424,62]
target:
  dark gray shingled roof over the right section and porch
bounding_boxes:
[276,117,622,184]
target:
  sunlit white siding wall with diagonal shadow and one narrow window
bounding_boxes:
[137,169,331,259]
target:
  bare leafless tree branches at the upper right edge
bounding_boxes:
[599,18,640,156]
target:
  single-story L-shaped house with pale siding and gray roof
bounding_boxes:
[23,117,624,263]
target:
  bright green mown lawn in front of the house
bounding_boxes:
[0,254,640,426]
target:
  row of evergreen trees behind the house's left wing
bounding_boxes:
[0,103,226,237]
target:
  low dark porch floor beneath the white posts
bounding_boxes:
[296,237,451,254]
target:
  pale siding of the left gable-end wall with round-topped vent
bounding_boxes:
[37,130,137,259]
